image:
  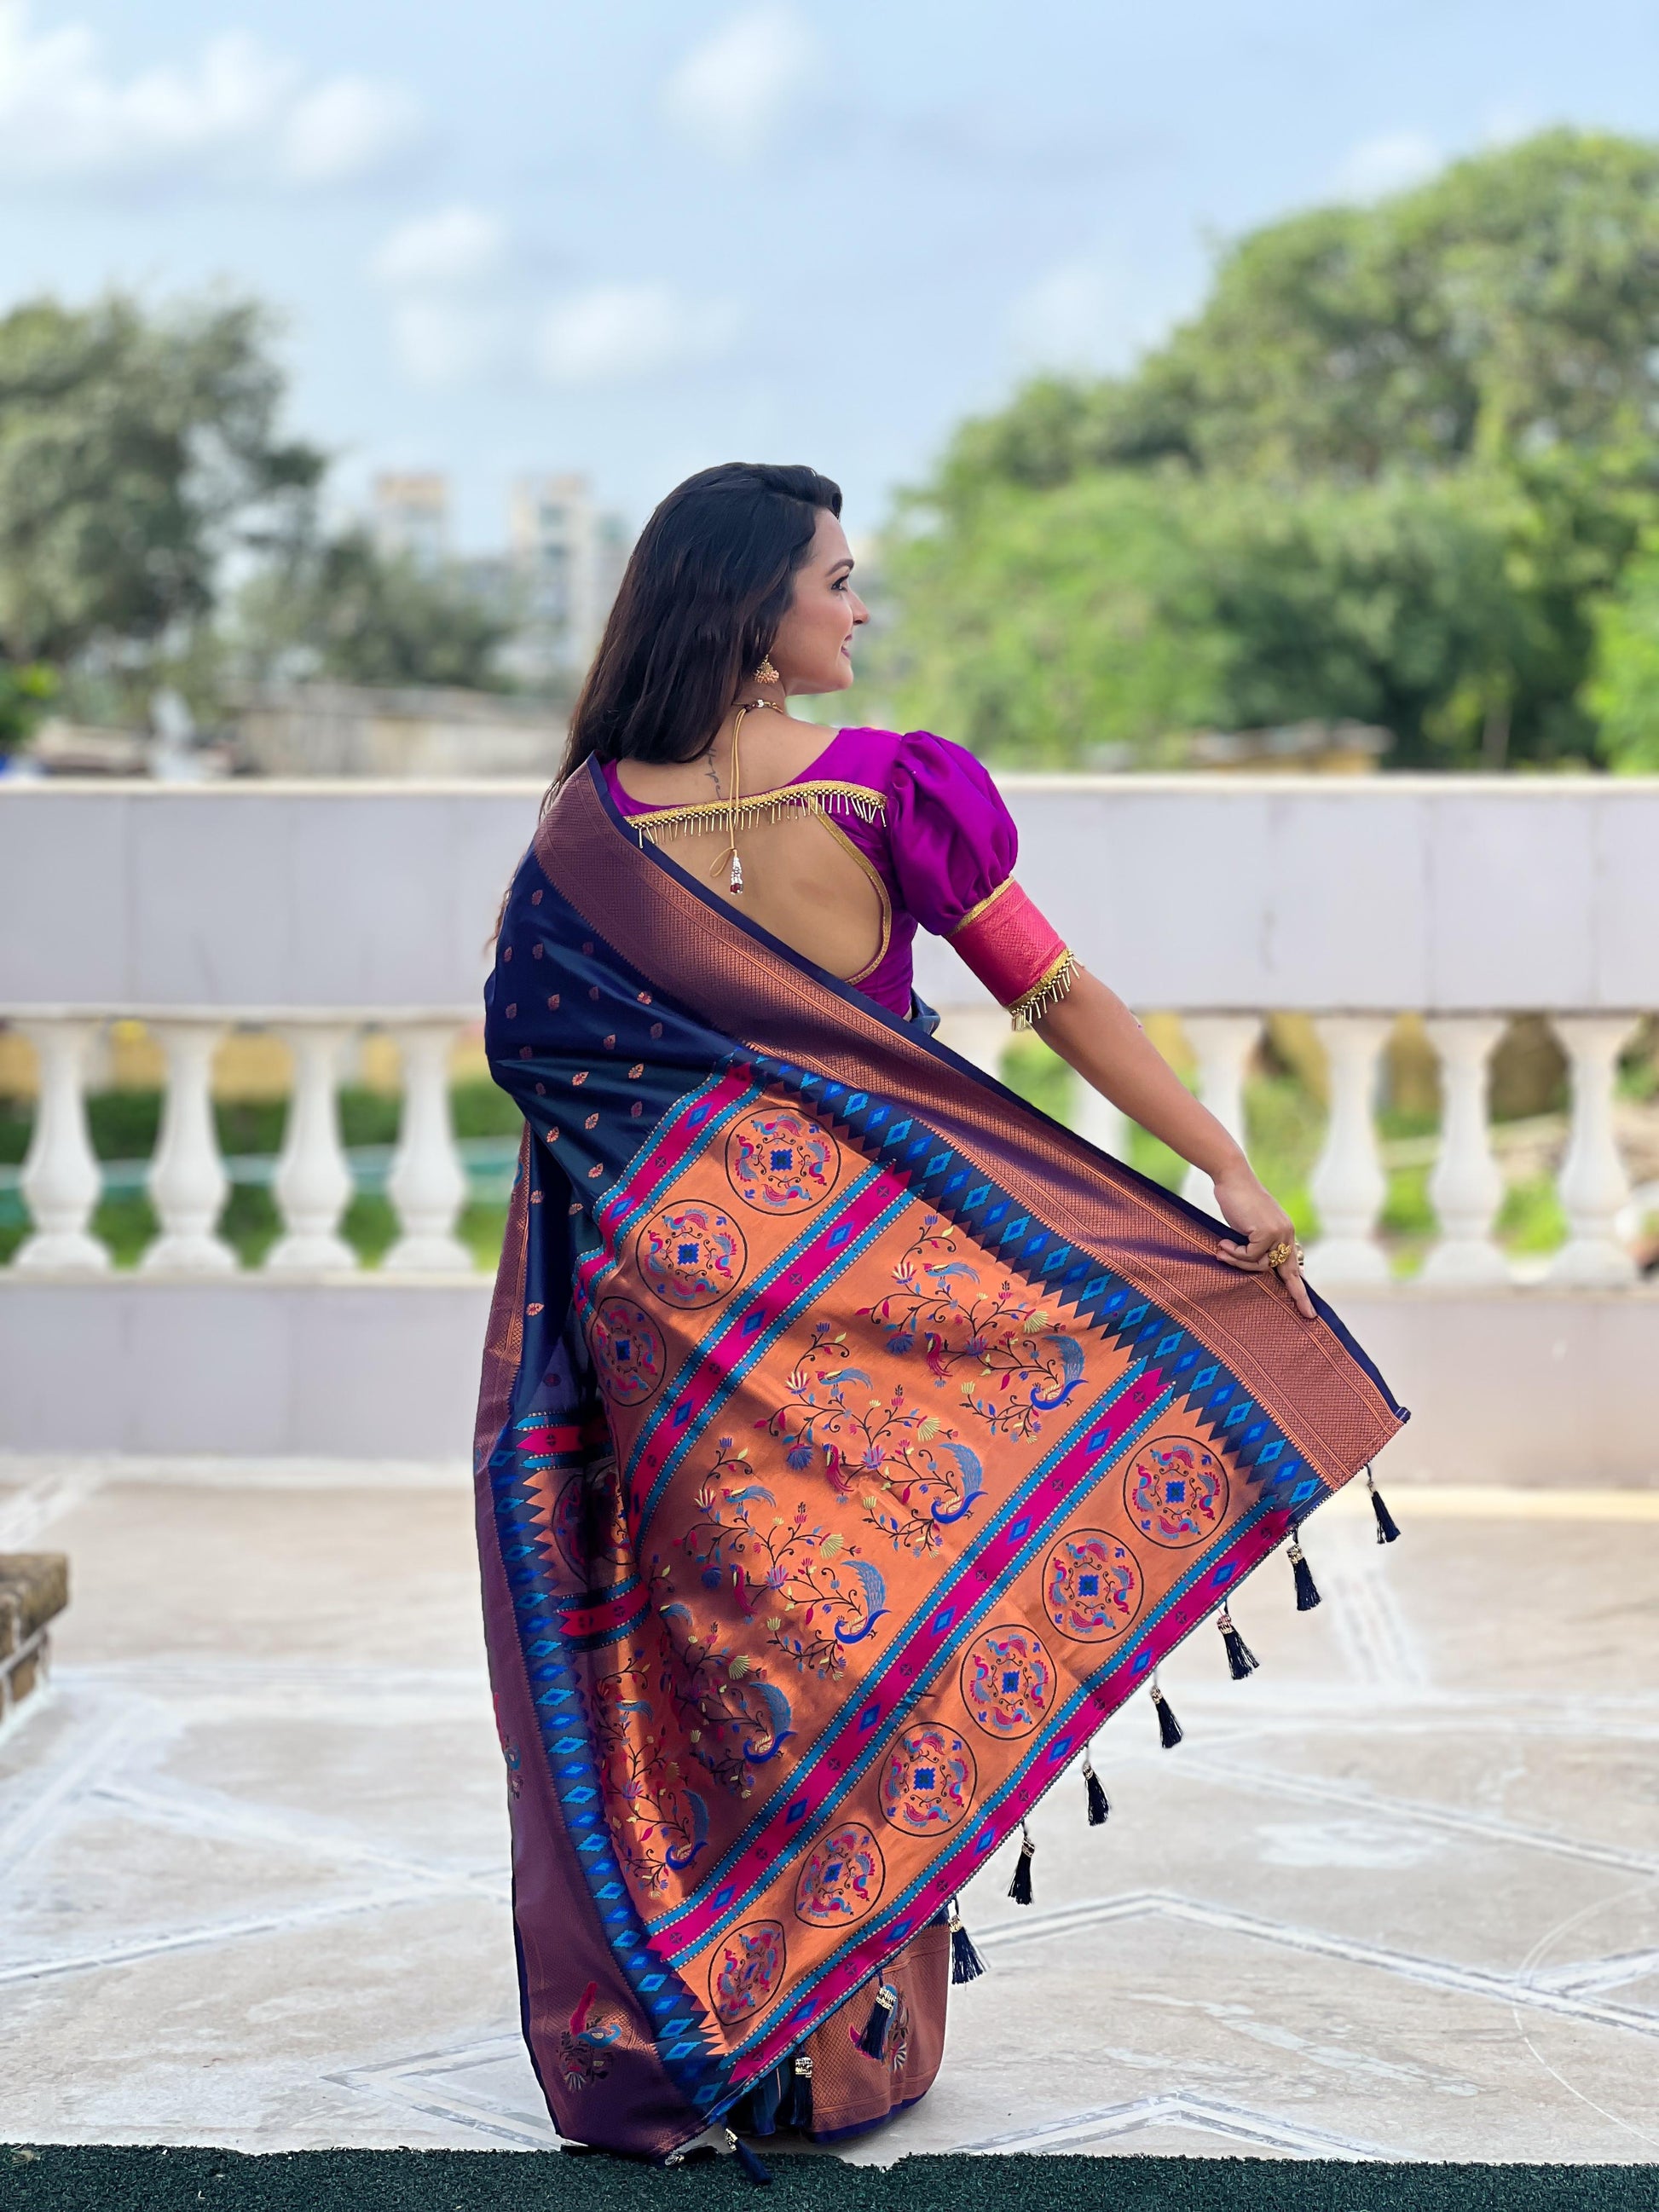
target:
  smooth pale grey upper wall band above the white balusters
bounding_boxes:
[0,777,1659,1011]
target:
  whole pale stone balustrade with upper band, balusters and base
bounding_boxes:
[0,777,1659,1480]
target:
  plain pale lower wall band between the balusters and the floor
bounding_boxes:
[0,1274,1659,1487]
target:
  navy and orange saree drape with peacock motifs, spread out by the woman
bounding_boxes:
[476,767,1405,2155]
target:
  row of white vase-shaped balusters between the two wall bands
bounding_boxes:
[0,1007,1637,1290]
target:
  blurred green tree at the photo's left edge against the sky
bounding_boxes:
[0,297,323,666]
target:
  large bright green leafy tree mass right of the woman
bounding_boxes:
[885,130,1659,765]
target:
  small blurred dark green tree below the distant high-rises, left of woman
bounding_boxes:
[232,531,513,690]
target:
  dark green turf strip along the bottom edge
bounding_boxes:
[0,2144,1659,2212]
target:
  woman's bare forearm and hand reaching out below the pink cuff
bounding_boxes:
[1033,969,1314,1320]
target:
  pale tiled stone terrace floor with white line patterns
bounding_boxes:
[0,1464,1659,2161]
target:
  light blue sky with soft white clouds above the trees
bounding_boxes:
[0,0,1659,551]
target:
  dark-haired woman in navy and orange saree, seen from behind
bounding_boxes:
[477,465,1405,2159]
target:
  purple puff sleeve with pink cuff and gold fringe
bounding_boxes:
[887,730,1078,1029]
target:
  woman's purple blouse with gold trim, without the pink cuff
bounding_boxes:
[604,730,1035,1018]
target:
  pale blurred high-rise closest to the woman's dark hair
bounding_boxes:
[505,473,628,684]
